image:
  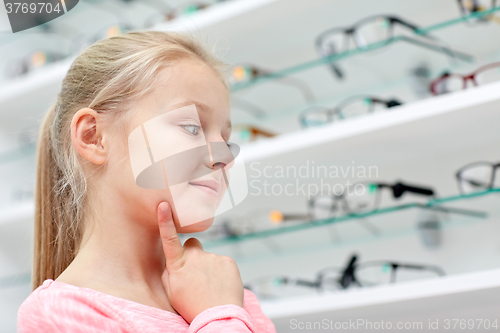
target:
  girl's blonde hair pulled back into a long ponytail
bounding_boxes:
[32,31,229,290]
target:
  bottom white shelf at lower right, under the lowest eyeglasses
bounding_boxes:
[260,269,500,320]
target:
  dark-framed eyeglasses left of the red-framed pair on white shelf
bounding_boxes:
[299,95,403,127]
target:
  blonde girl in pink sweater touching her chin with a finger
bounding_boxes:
[18,31,275,333]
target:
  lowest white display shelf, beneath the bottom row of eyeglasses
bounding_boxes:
[260,269,500,321]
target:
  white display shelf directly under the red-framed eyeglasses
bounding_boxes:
[237,82,500,165]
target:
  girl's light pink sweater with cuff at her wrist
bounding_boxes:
[17,279,276,333]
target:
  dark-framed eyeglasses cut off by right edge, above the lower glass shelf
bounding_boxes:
[455,162,500,194]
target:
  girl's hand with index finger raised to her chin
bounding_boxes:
[158,202,243,323]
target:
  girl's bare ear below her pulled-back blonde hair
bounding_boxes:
[71,108,108,165]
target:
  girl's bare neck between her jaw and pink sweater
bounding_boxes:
[56,193,177,313]
